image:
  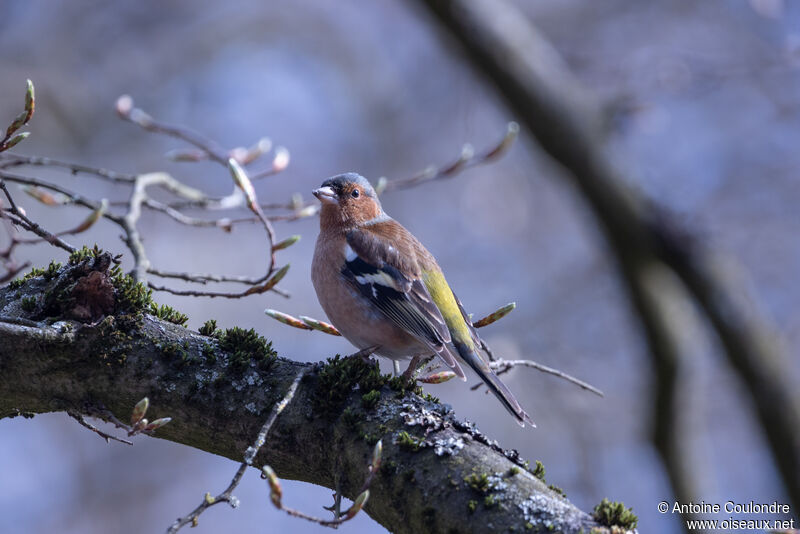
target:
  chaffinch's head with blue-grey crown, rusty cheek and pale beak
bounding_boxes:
[313,172,386,228]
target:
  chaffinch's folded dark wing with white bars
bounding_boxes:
[342,228,464,377]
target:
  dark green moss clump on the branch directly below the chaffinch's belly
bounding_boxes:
[314,355,388,414]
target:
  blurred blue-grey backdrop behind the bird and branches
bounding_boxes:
[0,0,800,533]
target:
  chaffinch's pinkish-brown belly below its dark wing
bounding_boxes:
[312,273,424,360]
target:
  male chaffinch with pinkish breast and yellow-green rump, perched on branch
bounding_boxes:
[311,173,536,427]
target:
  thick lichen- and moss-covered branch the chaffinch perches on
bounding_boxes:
[0,254,620,533]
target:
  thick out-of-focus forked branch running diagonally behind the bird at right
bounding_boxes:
[420,0,800,524]
